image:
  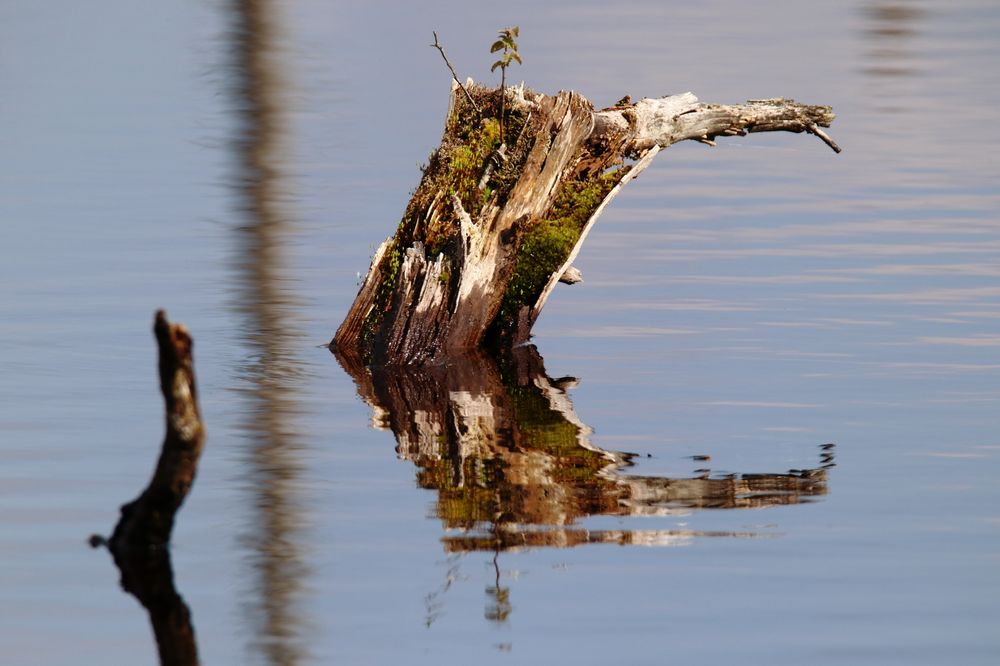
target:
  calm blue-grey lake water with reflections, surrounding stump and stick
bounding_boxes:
[0,0,1000,666]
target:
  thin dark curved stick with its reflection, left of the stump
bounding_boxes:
[91,310,205,665]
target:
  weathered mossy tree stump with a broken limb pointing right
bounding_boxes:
[330,81,840,365]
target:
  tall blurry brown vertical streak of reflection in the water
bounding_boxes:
[231,0,304,664]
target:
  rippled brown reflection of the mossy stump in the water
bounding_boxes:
[339,346,829,550]
